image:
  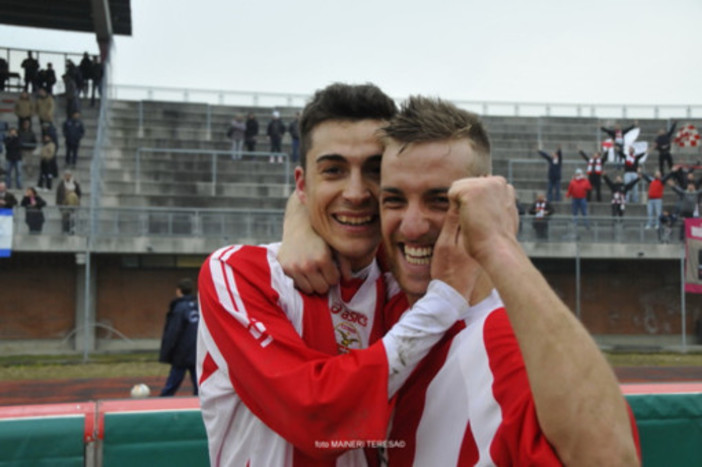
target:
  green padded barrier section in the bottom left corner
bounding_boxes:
[0,415,85,467]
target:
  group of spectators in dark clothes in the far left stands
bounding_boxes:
[0,52,91,234]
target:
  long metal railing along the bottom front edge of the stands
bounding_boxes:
[8,206,682,244]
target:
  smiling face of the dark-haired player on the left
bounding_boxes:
[295,120,384,271]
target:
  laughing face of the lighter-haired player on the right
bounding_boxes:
[380,138,477,303]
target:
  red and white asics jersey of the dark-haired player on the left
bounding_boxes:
[198,244,467,467]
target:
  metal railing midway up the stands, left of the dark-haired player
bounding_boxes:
[134,148,292,196]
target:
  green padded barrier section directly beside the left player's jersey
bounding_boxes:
[102,410,209,467]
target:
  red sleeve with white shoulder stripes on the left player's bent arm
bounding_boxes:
[199,247,390,458]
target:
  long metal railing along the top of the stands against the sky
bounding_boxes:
[110,84,702,119]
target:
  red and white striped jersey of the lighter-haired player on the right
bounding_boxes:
[387,291,561,466]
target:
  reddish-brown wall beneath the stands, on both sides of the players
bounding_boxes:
[0,253,702,353]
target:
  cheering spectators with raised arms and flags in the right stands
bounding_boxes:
[532,121,702,242]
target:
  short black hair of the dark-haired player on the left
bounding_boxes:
[300,83,397,168]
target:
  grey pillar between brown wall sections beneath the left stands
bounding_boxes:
[75,253,97,352]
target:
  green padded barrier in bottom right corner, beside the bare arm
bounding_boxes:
[627,394,702,467]
